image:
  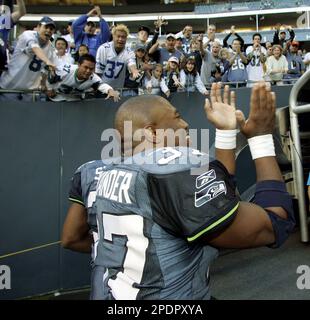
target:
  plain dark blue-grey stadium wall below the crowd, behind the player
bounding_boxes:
[0,86,291,299]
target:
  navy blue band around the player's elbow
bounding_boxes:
[253,180,295,248]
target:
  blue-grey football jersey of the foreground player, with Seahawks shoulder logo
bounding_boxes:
[94,147,239,300]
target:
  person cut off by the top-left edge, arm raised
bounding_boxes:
[0,0,26,75]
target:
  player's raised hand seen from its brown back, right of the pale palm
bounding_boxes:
[236,82,276,138]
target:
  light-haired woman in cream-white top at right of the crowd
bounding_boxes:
[266,45,288,85]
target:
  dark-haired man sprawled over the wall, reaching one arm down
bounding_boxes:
[47,54,119,102]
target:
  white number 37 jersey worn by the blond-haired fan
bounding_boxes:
[96,41,136,89]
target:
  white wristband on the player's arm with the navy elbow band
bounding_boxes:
[248,134,276,160]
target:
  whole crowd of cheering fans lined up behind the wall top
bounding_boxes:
[0,0,310,101]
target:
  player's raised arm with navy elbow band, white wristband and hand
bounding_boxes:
[207,83,295,248]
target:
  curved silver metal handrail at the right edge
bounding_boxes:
[289,71,310,242]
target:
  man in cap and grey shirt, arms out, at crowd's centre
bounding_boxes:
[149,33,184,68]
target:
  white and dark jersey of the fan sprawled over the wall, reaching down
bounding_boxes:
[48,65,112,101]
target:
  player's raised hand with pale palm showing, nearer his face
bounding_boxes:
[204,83,237,130]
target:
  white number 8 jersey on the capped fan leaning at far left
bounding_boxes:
[0,31,56,90]
